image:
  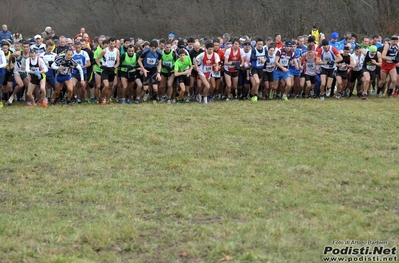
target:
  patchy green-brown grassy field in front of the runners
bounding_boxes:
[0,98,399,263]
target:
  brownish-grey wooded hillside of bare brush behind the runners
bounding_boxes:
[0,0,399,39]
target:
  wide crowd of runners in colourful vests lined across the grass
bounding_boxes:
[0,25,399,107]
